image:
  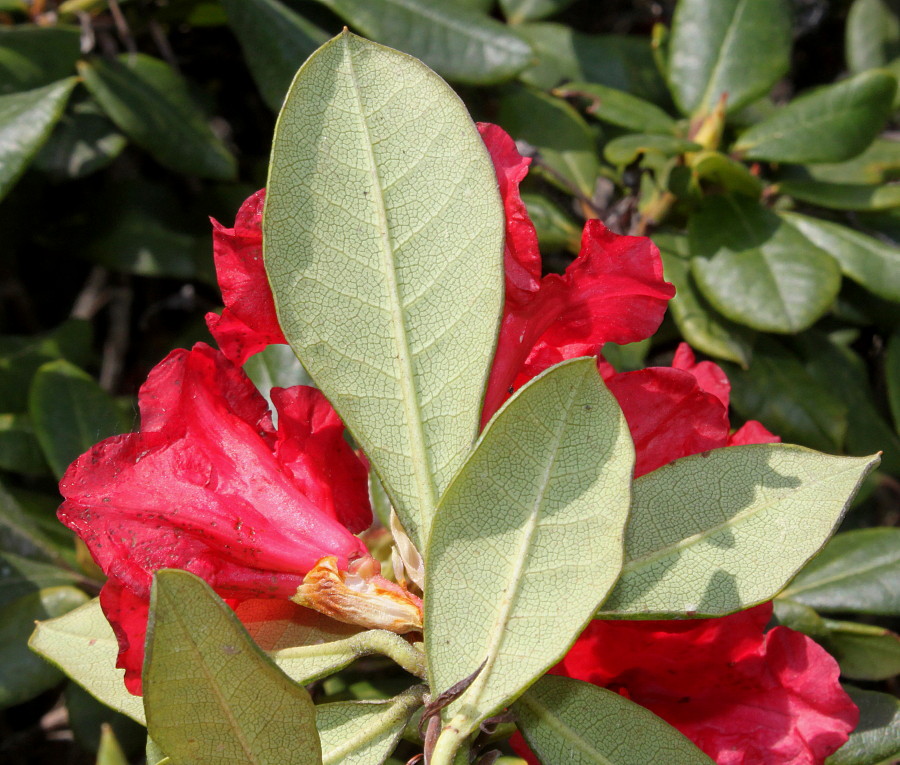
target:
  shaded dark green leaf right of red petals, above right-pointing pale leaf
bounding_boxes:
[726,337,847,452]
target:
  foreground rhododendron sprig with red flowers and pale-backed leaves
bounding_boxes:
[36,32,877,765]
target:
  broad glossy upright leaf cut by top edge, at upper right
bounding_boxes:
[668,0,791,114]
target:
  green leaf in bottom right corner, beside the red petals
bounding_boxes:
[825,685,900,765]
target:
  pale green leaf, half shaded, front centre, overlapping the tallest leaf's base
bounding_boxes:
[425,358,634,737]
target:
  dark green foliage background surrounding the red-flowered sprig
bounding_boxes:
[0,0,900,763]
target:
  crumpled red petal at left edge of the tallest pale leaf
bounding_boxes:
[206,189,287,365]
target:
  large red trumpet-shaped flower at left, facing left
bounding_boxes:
[59,343,418,693]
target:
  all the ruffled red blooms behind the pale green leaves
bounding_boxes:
[60,125,858,765]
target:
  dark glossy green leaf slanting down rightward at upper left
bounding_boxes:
[78,53,237,181]
